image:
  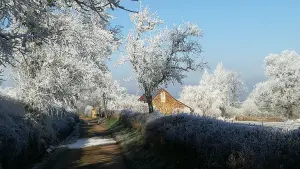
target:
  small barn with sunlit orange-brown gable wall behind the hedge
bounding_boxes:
[138,89,193,114]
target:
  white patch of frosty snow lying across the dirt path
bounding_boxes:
[60,137,116,149]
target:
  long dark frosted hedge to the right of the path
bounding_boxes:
[116,111,300,169]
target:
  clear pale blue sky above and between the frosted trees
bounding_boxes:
[108,0,300,97]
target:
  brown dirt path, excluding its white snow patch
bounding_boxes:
[42,119,126,169]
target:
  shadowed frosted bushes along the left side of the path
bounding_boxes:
[0,98,78,169]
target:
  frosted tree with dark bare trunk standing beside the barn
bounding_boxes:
[122,8,204,113]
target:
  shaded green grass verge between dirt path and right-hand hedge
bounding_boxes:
[105,117,172,169]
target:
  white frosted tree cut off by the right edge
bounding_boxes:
[246,50,300,118]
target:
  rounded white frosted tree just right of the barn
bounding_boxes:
[180,63,246,116]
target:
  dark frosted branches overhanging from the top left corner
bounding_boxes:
[0,0,137,64]
